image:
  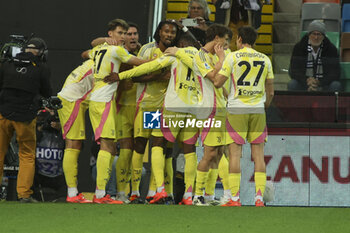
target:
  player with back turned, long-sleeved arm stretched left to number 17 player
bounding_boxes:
[106,34,201,204]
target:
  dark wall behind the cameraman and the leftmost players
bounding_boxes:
[0,0,152,191]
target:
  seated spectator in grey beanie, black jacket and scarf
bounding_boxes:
[288,20,341,91]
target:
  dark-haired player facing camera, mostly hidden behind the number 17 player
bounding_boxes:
[91,22,141,203]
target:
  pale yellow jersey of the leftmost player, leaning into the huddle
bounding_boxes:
[57,59,94,102]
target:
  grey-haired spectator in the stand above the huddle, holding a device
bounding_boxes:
[181,0,212,45]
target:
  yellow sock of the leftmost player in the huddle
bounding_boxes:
[62,148,80,188]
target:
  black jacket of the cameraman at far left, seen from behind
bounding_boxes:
[0,53,52,122]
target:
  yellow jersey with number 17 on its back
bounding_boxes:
[89,43,133,102]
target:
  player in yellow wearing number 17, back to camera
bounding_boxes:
[89,19,145,204]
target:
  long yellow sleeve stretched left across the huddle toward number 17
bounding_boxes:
[119,56,176,80]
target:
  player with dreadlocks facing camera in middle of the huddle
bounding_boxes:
[130,21,178,202]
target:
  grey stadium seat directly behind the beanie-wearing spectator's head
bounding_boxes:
[301,3,341,32]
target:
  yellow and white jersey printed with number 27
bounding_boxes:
[219,47,274,114]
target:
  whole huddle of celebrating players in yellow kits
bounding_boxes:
[58,19,274,206]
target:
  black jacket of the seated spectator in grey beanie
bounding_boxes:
[289,35,340,86]
